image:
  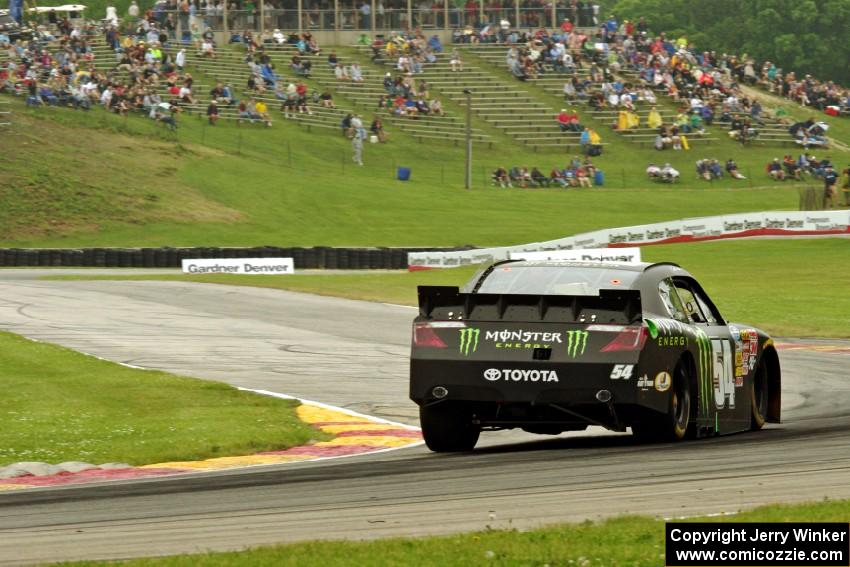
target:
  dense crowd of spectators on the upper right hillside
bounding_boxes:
[462,16,848,149]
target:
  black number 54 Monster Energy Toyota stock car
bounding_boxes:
[410,260,781,451]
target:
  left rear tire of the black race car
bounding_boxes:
[419,402,481,453]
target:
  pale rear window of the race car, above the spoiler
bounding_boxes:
[470,264,640,296]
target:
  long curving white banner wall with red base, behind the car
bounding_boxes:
[407,211,850,270]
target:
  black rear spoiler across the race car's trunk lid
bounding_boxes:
[419,286,643,325]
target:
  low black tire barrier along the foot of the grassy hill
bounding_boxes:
[0,246,472,270]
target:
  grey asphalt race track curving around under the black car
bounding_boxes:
[0,270,850,564]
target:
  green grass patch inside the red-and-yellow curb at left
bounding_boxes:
[0,333,326,466]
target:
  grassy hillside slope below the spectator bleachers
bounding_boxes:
[0,90,832,247]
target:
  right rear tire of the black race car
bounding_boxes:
[632,360,693,441]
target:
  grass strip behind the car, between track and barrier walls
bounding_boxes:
[44,238,850,337]
